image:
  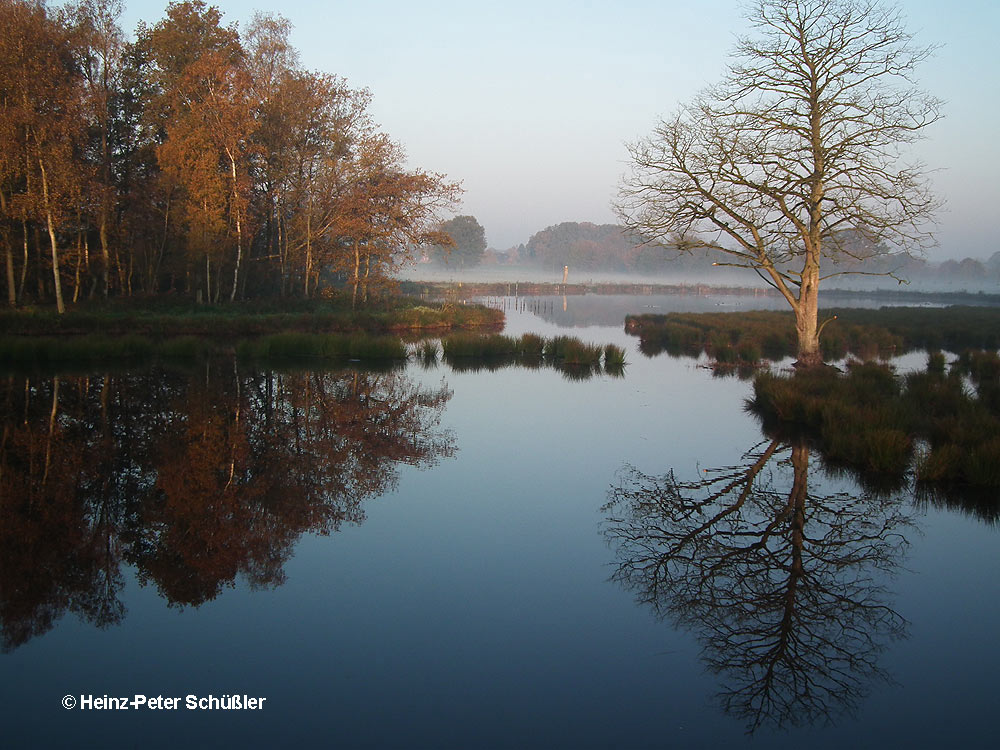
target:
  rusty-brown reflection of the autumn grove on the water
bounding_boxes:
[0,363,455,651]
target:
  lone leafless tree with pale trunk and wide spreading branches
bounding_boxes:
[617,0,941,366]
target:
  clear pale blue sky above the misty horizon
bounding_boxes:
[121,0,1000,261]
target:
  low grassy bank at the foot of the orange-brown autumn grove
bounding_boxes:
[0,298,504,366]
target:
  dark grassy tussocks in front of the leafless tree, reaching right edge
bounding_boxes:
[749,351,1000,506]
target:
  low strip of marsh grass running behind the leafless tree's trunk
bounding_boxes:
[625,307,1000,371]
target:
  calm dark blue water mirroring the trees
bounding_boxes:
[0,298,1000,748]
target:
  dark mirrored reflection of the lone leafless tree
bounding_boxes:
[604,440,912,732]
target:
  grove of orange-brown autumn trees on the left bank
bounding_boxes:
[0,0,460,311]
